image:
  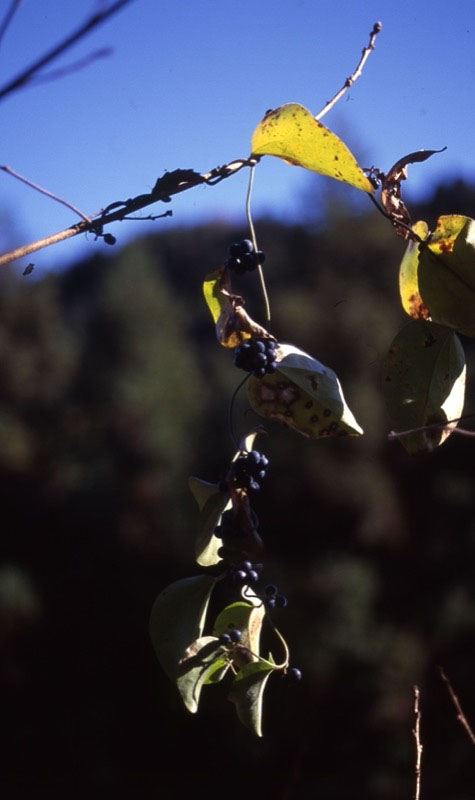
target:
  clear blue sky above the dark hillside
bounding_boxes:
[0,0,475,274]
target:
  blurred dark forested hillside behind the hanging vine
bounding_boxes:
[0,181,475,800]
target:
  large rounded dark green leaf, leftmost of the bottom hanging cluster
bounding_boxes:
[150,575,217,681]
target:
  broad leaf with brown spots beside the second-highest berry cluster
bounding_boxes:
[248,344,363,439]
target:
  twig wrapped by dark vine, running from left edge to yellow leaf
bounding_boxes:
[0,158,259,266]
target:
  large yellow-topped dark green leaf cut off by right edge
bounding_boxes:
[418,214,475,336]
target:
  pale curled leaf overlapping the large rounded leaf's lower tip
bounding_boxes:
[176,636,223,714]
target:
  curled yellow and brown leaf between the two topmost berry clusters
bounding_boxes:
[203,267,273,348]
